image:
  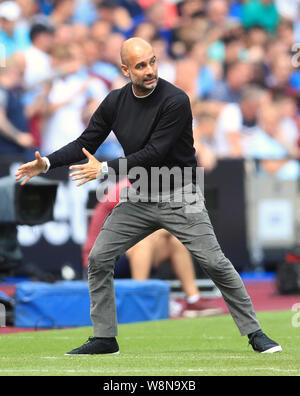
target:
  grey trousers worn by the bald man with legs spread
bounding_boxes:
[88,188,261,337]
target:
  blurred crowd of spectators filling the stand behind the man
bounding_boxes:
[0,0,300,178]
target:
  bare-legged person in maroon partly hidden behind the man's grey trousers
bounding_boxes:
[82,178,222,314]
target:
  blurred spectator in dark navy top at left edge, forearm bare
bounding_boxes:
[0,59,33,158]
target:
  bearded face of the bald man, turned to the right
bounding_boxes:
[122,48,158,95]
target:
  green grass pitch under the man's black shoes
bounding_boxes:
[0,311,300,377]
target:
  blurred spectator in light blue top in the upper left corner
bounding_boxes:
[0,1,30,58]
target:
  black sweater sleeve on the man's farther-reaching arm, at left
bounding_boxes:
[47,95,113,169]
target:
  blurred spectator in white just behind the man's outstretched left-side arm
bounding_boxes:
[41,43,107,154]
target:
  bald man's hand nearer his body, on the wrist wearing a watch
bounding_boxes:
[69,148,102,187]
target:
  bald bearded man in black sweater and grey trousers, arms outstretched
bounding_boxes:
[16,38,281,355]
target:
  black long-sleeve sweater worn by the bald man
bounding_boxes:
[48,78,197,192]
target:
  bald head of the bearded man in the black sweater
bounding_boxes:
[121,37,158,96]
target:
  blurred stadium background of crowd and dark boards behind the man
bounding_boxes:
[0,0,300,332]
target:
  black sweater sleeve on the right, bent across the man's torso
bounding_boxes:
[108,93,192,174]
